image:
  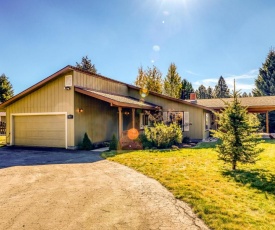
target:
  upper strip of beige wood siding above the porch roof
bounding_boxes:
[74,71,128,96]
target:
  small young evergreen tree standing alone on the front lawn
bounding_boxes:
[213,82,262,170]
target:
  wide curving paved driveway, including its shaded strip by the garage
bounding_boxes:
[0,148,208,230]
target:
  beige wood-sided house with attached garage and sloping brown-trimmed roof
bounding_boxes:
[0,66,212,149]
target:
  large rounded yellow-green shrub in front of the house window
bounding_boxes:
[145,122,182,148]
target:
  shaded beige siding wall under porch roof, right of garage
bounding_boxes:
[74,93,118,145]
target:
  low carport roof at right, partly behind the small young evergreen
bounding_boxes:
[194,96,275,113]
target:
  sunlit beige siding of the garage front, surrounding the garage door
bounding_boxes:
[6,72,75,147]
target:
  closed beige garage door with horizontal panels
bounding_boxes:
[13,114,66,148]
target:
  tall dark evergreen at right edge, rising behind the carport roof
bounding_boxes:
[252,49,275,132]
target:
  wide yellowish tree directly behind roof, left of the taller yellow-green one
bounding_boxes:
[135,66,163,93]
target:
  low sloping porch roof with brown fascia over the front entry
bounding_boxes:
[74,86,161,110]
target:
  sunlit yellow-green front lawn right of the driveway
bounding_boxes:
[103,140,275,230]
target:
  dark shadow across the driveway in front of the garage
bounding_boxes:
[0,146,103,169]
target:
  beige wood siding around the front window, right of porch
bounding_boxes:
[129,88,205,139]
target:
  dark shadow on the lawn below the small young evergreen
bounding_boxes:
[223,169,275,194]
